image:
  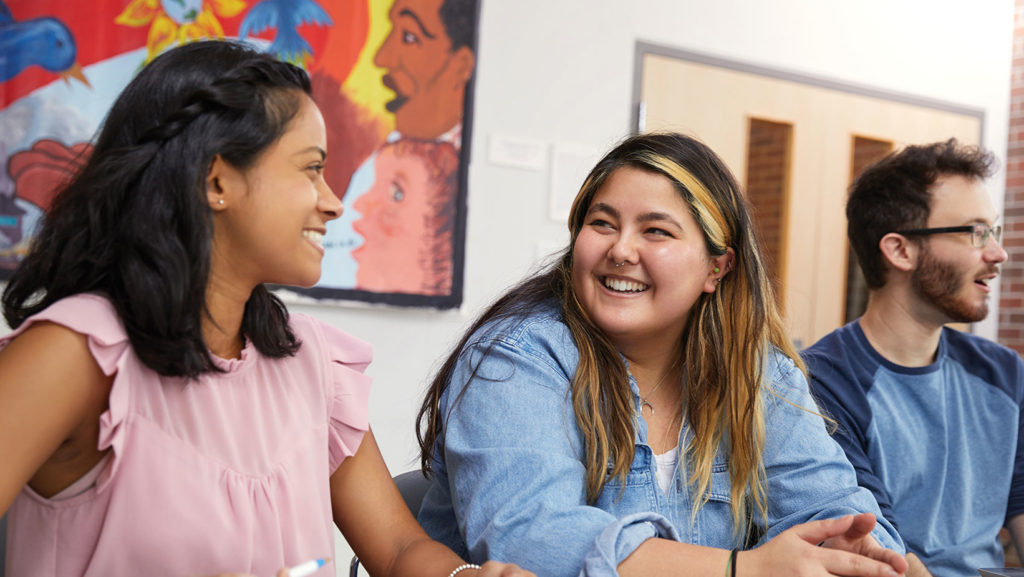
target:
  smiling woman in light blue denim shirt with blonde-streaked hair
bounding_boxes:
[411,134,906,576]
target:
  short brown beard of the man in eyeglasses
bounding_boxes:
[910,243,988,323]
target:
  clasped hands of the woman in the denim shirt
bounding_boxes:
[736,513,906,577]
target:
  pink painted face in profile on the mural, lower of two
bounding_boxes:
[352,141,458,294]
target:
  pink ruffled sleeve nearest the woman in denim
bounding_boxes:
[303,315,373,473]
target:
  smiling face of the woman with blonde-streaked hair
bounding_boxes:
[572,167,716,349]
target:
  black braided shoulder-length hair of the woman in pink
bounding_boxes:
[3,41,310,377]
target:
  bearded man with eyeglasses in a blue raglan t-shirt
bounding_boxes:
[803,139,1024,577]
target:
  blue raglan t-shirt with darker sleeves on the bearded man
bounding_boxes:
[802,321,1024,577]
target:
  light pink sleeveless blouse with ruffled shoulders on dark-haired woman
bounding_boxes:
[0,294,371,577]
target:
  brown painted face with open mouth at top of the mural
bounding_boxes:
[374,0,475,138]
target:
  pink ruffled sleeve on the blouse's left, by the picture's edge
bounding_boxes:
[0,293,131,491]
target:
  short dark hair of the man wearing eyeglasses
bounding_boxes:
[846,138,994,289]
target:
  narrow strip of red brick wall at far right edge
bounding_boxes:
[998,0,1024,355]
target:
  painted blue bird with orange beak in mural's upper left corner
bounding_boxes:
[0,0,91,86]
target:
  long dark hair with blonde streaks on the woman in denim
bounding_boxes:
[417,133,803,532]
